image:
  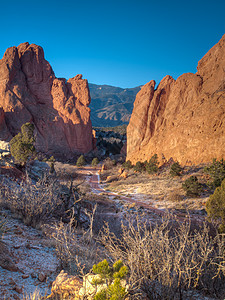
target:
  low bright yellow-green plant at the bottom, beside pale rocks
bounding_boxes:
[92,259,127,300]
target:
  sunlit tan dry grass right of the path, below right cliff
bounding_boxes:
[101,166,209,213]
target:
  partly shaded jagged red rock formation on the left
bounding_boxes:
[0,43,92,156]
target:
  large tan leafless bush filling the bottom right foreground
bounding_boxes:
[100,215,225,299]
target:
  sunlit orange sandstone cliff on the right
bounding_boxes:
[127,35,225,164]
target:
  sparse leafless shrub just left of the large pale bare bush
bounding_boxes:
[44,206,105,276]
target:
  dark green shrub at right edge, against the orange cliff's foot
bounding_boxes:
[204,158,225,189]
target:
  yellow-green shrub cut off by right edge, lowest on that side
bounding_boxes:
[206,179,225,233]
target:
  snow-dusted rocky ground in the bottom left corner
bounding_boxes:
[0,210,60,300]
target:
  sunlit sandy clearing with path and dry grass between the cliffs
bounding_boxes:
[55,163,209,215]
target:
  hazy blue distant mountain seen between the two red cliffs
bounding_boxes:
[89,83,141,127]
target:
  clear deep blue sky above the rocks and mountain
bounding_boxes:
[0,0,225,87]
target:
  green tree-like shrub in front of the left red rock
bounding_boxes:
[10,123,35,165]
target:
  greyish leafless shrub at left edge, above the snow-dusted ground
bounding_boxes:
[1,178,65,227]
